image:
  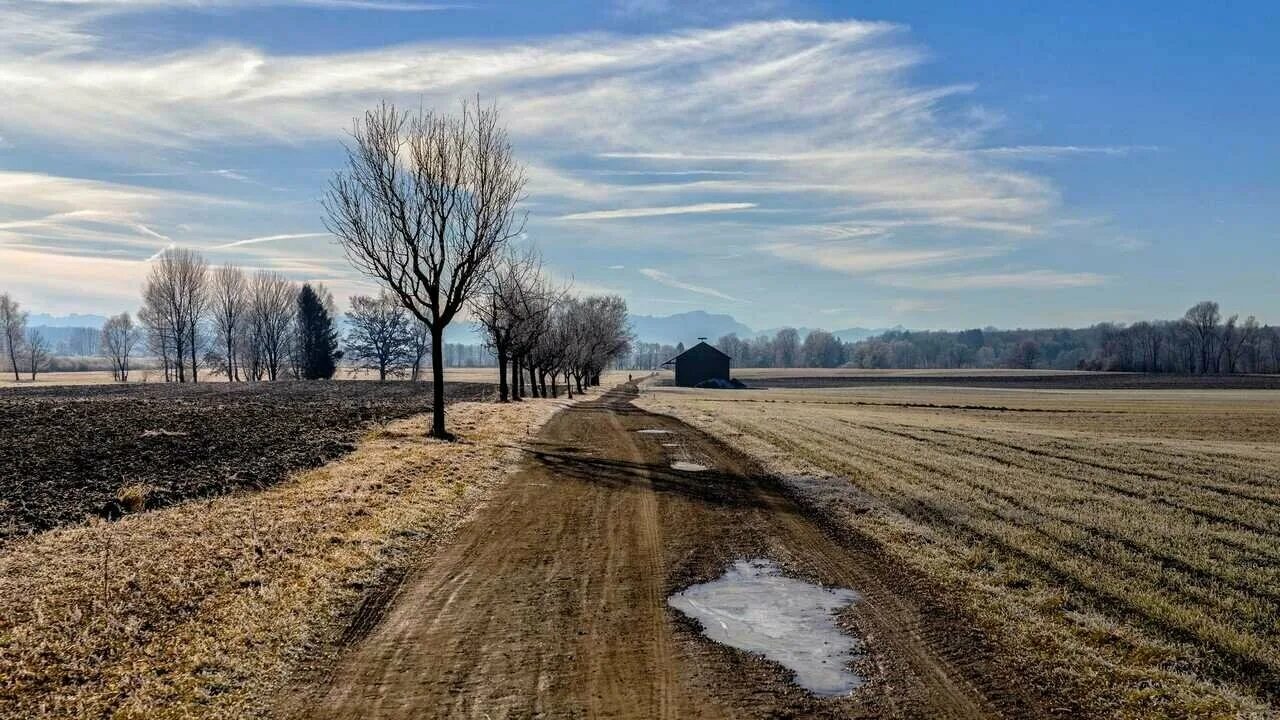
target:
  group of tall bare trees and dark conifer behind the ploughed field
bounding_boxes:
[132,249,342,383]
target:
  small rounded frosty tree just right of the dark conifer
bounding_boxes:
[346,292,420,380]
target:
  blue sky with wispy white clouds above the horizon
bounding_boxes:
[0,0,1280,328]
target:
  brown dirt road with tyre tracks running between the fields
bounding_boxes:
[280,386,1043,720]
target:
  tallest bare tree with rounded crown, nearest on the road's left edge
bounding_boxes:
[324,102,525,438]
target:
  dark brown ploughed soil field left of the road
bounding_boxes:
[0,382,493,542]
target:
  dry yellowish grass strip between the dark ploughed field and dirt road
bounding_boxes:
[0,392,578,719]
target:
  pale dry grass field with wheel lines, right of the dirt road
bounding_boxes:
[641,387,1280,717]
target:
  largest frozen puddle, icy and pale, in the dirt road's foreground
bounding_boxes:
[667,560,864,697]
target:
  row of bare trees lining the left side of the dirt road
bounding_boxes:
[324,101,630,438]
